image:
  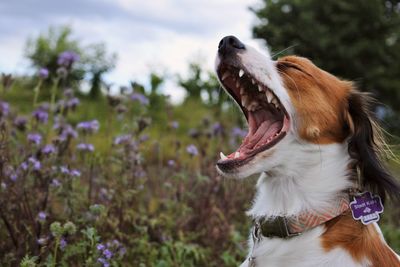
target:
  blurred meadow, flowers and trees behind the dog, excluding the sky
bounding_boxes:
[0,0,400,267]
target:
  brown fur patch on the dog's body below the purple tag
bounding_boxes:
[321,212,400,267]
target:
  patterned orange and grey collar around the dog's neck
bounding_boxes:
[253,194,349,240]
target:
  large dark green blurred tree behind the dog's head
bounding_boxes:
[252,0,400,114]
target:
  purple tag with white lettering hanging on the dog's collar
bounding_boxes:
[350,192,383,225]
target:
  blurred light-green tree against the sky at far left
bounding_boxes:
[26,26,116,97]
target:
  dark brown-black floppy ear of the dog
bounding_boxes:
[347,90,400,202]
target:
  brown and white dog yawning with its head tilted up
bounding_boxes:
[216,36,400,267]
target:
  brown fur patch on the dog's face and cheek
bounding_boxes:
[278,56,352,144]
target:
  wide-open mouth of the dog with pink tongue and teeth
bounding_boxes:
[217,66,289,168]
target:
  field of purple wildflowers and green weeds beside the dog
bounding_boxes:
[0,53,400,267]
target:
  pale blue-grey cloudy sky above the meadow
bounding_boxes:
[0,0,268,101]
